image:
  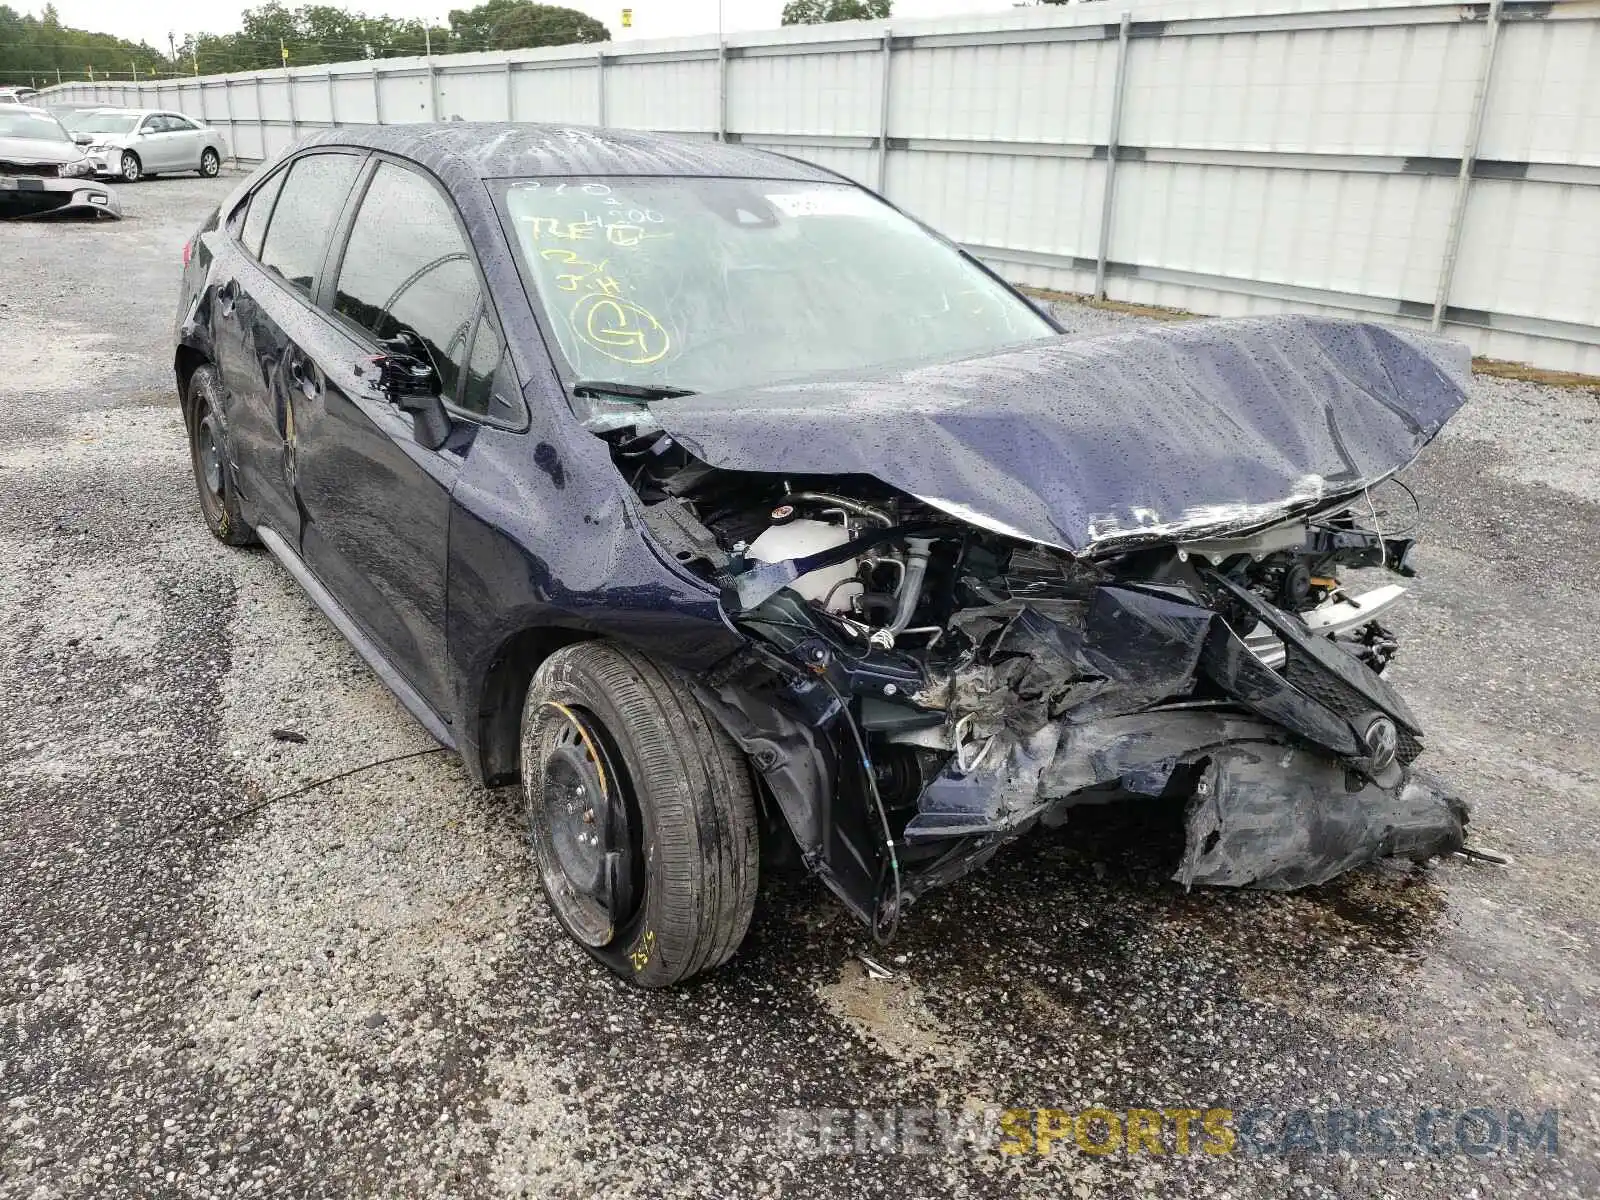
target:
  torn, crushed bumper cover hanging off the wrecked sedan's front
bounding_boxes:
[906,576,1467,888]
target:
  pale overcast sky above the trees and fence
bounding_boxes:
[50,0,1014,48]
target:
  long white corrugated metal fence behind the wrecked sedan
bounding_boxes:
[34,0,1600,373]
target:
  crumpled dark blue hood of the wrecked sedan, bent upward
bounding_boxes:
[651,315,1470,552]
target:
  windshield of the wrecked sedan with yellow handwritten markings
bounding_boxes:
[504,179,1054,392]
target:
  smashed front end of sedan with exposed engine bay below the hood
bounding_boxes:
[590,410,1466,938]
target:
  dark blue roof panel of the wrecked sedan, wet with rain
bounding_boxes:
[297,122,837,187]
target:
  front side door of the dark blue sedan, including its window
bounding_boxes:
[294,158,486,714]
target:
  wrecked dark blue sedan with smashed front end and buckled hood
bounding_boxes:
[174,123,1469,987]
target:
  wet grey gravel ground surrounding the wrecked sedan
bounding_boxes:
[0,178,1600,1198]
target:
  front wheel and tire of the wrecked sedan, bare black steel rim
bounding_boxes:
[522,642,758,987]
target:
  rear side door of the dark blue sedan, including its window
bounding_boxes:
[211,150,365,546]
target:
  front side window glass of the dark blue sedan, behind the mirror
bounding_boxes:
[336,163,480,402]
